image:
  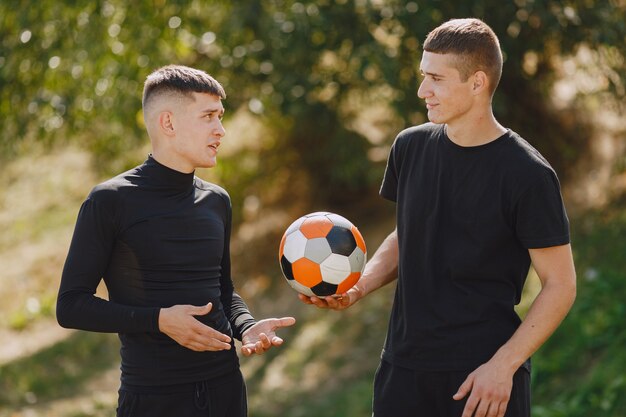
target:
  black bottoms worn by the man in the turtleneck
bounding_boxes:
[116,371,248,417]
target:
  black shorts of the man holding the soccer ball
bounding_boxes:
[372,360,530,417]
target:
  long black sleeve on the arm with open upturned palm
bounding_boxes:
[220,194,256,340]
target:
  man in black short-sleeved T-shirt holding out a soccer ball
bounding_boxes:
[300,19,576,417]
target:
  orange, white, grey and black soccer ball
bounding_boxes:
[278,212,367,297]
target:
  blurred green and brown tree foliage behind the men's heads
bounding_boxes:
[0,0,626,210]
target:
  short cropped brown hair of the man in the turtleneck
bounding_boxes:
[142,65,226,110]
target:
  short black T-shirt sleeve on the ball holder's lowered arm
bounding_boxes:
[515,171,570,249]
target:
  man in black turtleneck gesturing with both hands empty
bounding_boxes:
[57,65,295,417]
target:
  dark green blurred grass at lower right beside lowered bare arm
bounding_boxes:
[533,210,626,417]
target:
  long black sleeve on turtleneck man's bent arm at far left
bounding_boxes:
[56,198,159,333]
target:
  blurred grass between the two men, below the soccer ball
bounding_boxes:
[242,287,393,417]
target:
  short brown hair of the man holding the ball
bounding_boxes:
[424,18,502,95]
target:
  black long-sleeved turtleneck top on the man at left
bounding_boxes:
[57,156,255,386]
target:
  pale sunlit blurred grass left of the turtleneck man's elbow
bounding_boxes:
[0,149,95,329]
